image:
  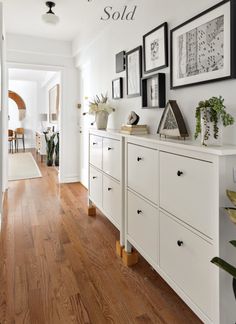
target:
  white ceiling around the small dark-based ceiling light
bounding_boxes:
[1,0,132,41]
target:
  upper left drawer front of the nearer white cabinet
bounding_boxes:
[128,144,158,204]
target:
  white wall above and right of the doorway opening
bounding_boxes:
[7,34,80,182]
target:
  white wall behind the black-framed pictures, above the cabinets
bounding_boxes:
[73,0,236,148]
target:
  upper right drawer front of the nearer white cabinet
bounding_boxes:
[160,152,215,237]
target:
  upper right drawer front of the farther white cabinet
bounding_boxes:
[103,138,121,180]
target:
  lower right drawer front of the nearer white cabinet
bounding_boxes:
[160,213,215,318]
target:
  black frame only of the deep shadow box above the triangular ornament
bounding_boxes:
[142,73,166,109]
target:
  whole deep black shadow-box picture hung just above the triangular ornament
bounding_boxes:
[142,73,166,108]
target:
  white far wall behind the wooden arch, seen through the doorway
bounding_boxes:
[8,80,38,149]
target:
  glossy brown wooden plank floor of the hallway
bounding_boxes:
[0,153,200,324]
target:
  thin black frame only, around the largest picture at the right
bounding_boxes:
[170,0,236,89]
